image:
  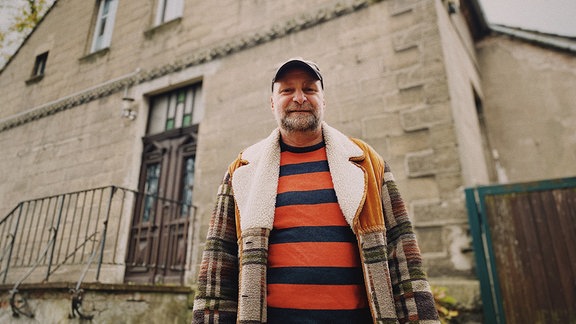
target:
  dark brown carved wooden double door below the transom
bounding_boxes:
[125,128,196,284]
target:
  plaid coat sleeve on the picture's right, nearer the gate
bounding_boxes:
[382,163,440,323]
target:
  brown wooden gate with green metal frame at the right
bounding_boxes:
[466,177,576,324]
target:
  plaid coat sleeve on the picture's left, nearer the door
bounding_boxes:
[193,172,238,323]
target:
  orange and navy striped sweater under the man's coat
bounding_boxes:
[267,142,372,323]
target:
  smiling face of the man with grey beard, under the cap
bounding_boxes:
[271,68,325,132]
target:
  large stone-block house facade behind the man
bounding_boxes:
[0,0,483,318]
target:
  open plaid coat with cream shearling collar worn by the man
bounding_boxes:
[193,123,439,323]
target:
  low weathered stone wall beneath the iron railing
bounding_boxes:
[0,285,193,324]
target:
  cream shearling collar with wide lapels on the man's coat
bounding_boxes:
[232,123,366,231]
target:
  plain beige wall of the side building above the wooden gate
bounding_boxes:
[478,34,576,183]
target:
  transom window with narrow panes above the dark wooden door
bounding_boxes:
[148,83,204,134]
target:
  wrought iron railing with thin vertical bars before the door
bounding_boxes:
[0,186,194,319]
